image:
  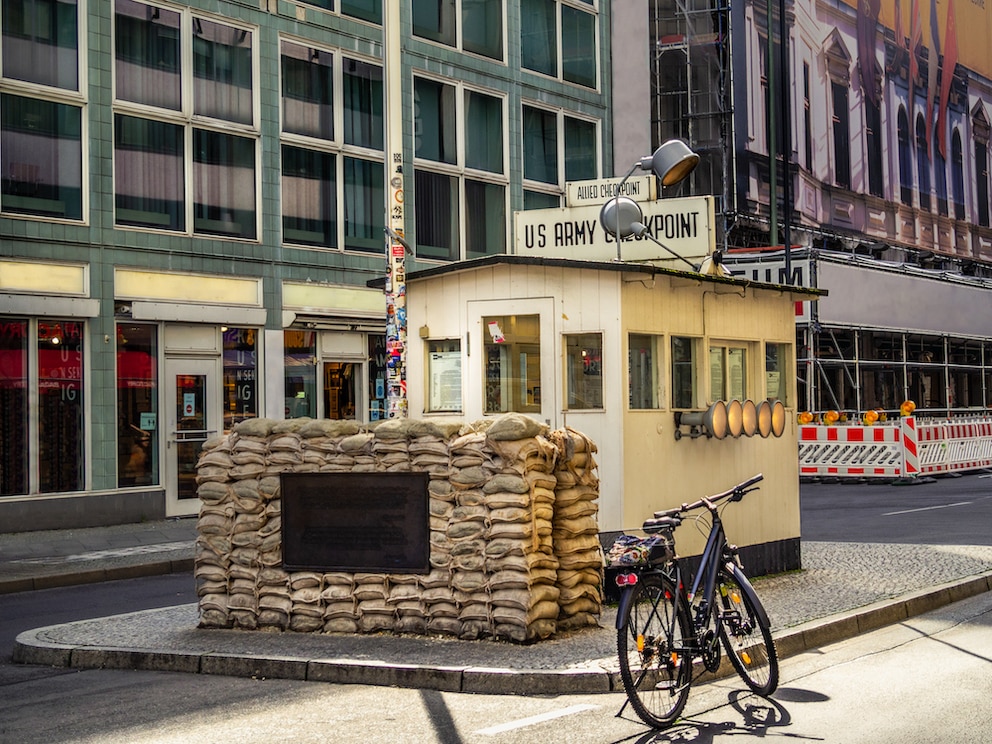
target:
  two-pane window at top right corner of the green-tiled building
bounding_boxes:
[520,0,599,88]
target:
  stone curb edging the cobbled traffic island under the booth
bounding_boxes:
[13,572,992,695]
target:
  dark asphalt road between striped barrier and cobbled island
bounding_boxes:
[799,473,992,545]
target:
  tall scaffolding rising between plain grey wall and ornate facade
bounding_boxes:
[649,0,736,246]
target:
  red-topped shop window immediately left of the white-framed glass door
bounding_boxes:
[117,323,159,487]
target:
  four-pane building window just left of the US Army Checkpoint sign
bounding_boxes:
[414,77,508,261]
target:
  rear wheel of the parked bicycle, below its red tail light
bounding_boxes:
[617,574,692,728]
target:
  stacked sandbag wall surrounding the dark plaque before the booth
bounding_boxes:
[195,414,603,642]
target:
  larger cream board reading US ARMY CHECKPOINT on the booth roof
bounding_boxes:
[514,196,716,266]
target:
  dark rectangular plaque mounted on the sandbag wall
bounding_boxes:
[281,473,430,574]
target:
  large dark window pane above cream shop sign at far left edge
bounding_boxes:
[0,93,83,220]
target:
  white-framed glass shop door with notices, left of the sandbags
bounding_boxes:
[165,359,221,516]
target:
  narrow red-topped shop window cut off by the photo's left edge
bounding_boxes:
[0,318,29,496]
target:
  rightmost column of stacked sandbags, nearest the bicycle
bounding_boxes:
[551,427,603,630]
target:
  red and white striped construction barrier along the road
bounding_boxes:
[799,416,992,478]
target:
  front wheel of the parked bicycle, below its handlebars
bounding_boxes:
[717,568,778,696]
